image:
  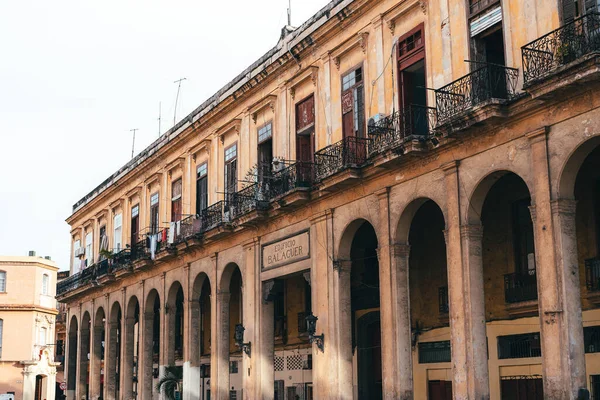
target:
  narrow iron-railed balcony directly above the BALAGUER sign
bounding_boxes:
[269,161,315,209]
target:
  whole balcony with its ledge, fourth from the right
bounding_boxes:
[315,136,370,190]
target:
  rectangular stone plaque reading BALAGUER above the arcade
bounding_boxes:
[261,231,310,270]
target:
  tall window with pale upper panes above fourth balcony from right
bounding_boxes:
[342,67,365,138]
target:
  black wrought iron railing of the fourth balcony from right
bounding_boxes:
[315,136,369,181]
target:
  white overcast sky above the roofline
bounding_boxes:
[0,0,328,269]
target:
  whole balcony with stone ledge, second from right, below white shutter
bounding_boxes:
[435,63,519,132]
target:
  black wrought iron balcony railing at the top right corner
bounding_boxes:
[521,12,600,85]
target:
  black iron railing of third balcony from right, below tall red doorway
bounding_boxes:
[369,104,436,157]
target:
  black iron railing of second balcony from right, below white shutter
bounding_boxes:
[435,63,519,126]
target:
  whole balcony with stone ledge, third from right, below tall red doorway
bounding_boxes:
[368,104,436,165]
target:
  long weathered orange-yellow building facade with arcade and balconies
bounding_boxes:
[58,0,600,399]
